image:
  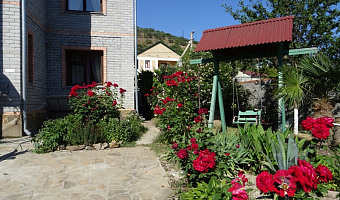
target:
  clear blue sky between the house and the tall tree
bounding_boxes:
[137,0,239,41]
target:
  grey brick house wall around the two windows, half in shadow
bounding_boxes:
[47,0,135,109]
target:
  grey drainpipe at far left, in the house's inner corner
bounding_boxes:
[21,0,32,136]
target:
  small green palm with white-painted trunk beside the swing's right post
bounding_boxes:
[275,65,308,135]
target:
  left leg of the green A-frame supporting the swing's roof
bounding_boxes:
[208,53,220,128]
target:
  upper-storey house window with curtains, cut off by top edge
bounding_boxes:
[67,0,102,12]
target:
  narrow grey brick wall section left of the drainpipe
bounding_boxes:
[0,0,21,137]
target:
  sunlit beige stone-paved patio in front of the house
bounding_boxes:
[0,121,171,200]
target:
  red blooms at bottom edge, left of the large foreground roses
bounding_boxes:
[228,171,249,200]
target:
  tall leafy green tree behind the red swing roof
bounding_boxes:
[224,0,340,59]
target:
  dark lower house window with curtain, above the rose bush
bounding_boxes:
[65,50,103,85]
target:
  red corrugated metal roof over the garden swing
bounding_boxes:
[195,16,294,52]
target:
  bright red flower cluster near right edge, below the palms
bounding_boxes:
[301,117,334,139]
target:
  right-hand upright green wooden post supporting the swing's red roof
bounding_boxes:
[278,42,286,132]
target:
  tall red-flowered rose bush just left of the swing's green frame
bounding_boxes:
[145,71,208,142]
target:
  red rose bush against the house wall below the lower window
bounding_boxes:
[68,82,126,123]
